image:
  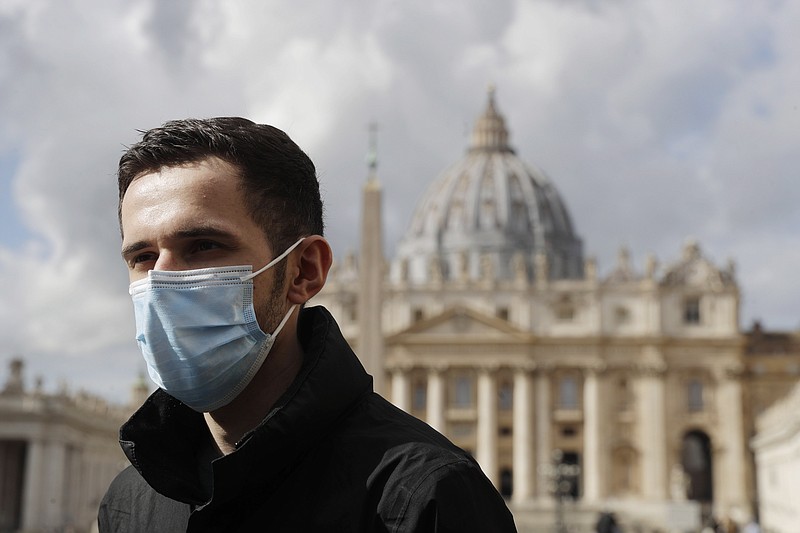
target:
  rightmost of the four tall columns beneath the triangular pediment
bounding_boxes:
[511,365,535,503]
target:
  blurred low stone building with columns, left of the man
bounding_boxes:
[0,359,135,533]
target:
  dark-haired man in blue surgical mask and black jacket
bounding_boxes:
[98,118,514,532]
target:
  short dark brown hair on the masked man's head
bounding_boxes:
[117,117,324,254]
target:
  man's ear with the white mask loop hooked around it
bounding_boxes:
[288,235,333,304]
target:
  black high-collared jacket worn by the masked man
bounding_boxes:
[98,307,515,533]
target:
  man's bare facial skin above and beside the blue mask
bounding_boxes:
[121,157,288,332]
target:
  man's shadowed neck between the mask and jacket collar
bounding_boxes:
[204,322,303,455]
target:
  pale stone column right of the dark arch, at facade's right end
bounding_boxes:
[713,367,753,517]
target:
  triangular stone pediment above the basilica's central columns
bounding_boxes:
[386,306,530,344]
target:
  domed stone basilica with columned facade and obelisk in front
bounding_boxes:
[312,91,753,528]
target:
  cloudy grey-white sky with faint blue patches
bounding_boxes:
[0,0,800,401]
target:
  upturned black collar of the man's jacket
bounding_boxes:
[120,307,372,506]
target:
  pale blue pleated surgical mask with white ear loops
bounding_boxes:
[129,239,303,412]
